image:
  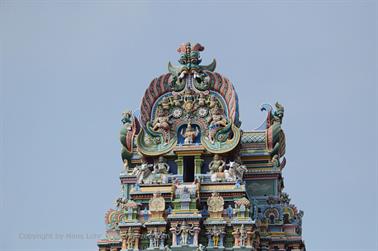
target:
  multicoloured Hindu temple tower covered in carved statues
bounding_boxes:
[97,43,305,251]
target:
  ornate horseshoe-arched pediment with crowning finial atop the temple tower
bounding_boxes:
[137,43,240,156]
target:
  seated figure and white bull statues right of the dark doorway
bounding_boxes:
[209,154,247,181]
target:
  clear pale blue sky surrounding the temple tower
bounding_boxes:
[0,0,378,251]
